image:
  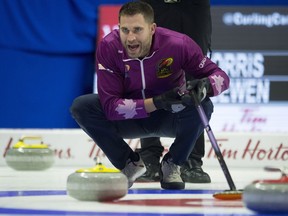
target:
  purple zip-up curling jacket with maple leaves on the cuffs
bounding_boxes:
[96,27,229,120]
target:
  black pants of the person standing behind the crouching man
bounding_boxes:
[139,0,212,166]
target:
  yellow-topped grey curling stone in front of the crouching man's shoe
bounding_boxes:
[67,163,128,202]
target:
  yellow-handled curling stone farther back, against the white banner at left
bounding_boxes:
[5,136,55,171]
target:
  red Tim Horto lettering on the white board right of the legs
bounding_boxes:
[207,139,288,161]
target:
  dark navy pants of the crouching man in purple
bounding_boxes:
[71,94,213,169]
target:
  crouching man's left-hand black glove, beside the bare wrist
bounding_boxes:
[153,88,185,113]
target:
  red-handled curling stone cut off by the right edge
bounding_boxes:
[243,168,288,214]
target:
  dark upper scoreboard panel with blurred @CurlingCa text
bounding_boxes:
[211,6,288,51]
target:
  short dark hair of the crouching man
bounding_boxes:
[118,1,154,23]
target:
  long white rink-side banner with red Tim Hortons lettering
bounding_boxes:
[0,129,288,168]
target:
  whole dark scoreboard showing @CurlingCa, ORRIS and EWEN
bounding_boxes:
[211,7,288,104]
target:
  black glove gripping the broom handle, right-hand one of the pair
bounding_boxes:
[182,78,211,106]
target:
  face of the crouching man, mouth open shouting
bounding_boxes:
[119,14,156,58]
